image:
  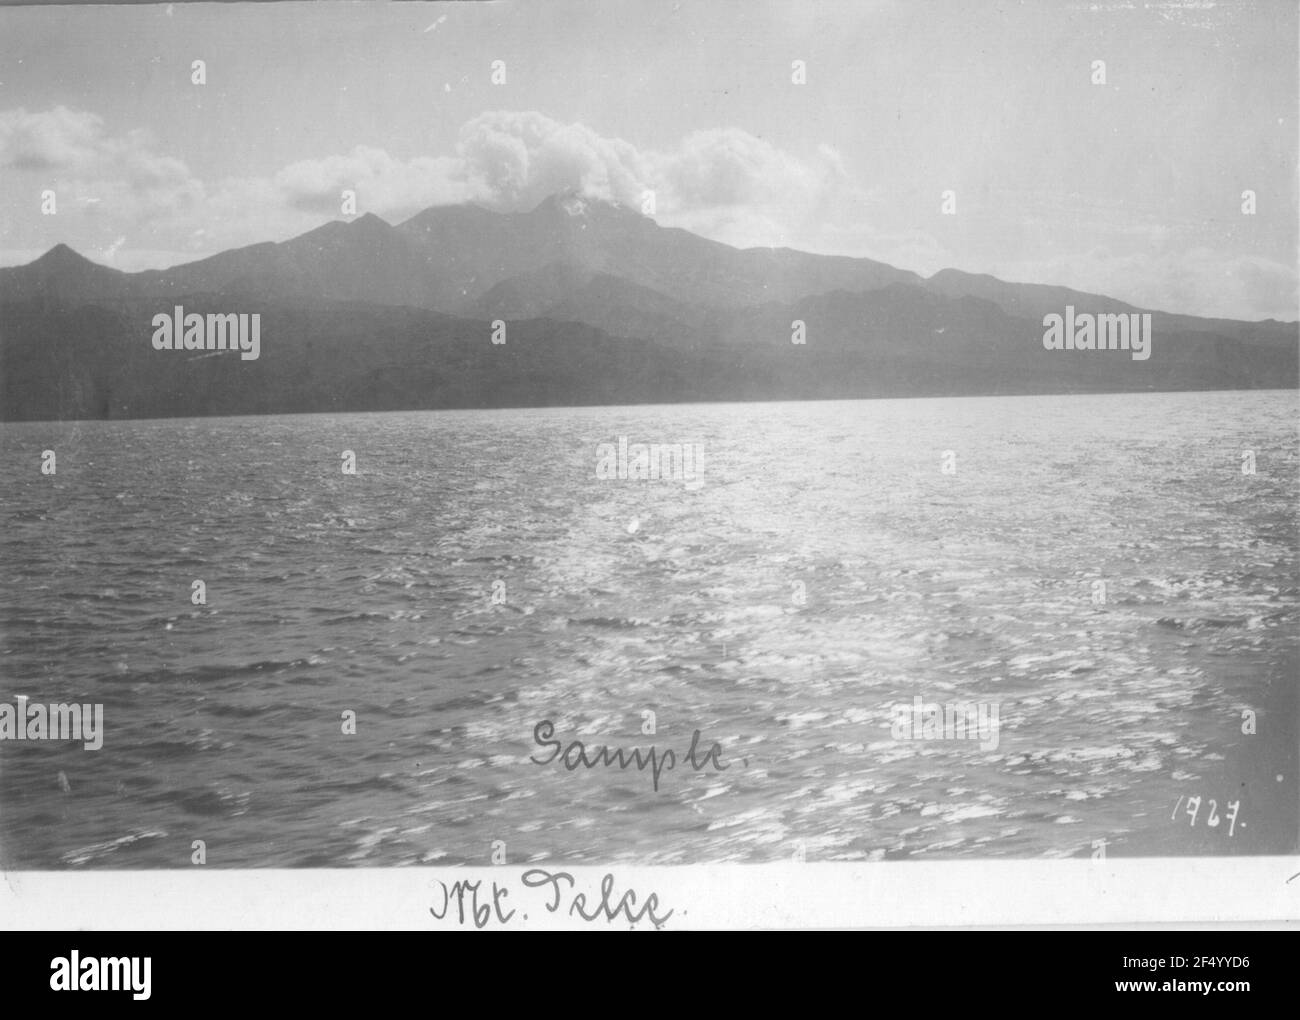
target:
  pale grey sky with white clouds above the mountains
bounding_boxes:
[0,0,1300,320]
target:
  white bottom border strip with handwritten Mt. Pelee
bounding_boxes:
[0,856,1300,925]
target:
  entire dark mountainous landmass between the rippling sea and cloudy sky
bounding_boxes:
[0,192,1300,421]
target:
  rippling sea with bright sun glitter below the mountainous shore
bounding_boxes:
[0,391,1300,868]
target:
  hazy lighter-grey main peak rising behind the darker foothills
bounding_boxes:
[0,192,920,313]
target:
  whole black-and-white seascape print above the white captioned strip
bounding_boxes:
[0,0,1300,928]
